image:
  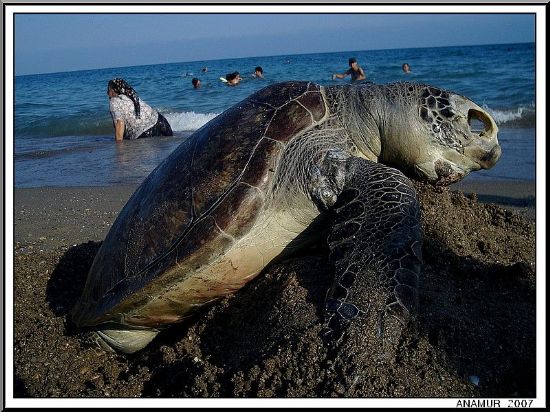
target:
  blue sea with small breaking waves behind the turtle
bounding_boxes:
[14,43,536,187]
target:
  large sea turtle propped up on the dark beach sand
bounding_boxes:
[72,81,501,353]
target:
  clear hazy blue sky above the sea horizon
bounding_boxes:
[14,14,535,75]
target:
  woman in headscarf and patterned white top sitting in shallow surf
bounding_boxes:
[107,78,173,142]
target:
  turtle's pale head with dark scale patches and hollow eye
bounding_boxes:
[379,83,501,185]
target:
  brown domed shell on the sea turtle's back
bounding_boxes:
[73,82,326,326]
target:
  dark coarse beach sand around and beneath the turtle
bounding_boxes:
[10,182,543,405]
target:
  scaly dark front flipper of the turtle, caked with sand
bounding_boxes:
[323,157,422,352]
